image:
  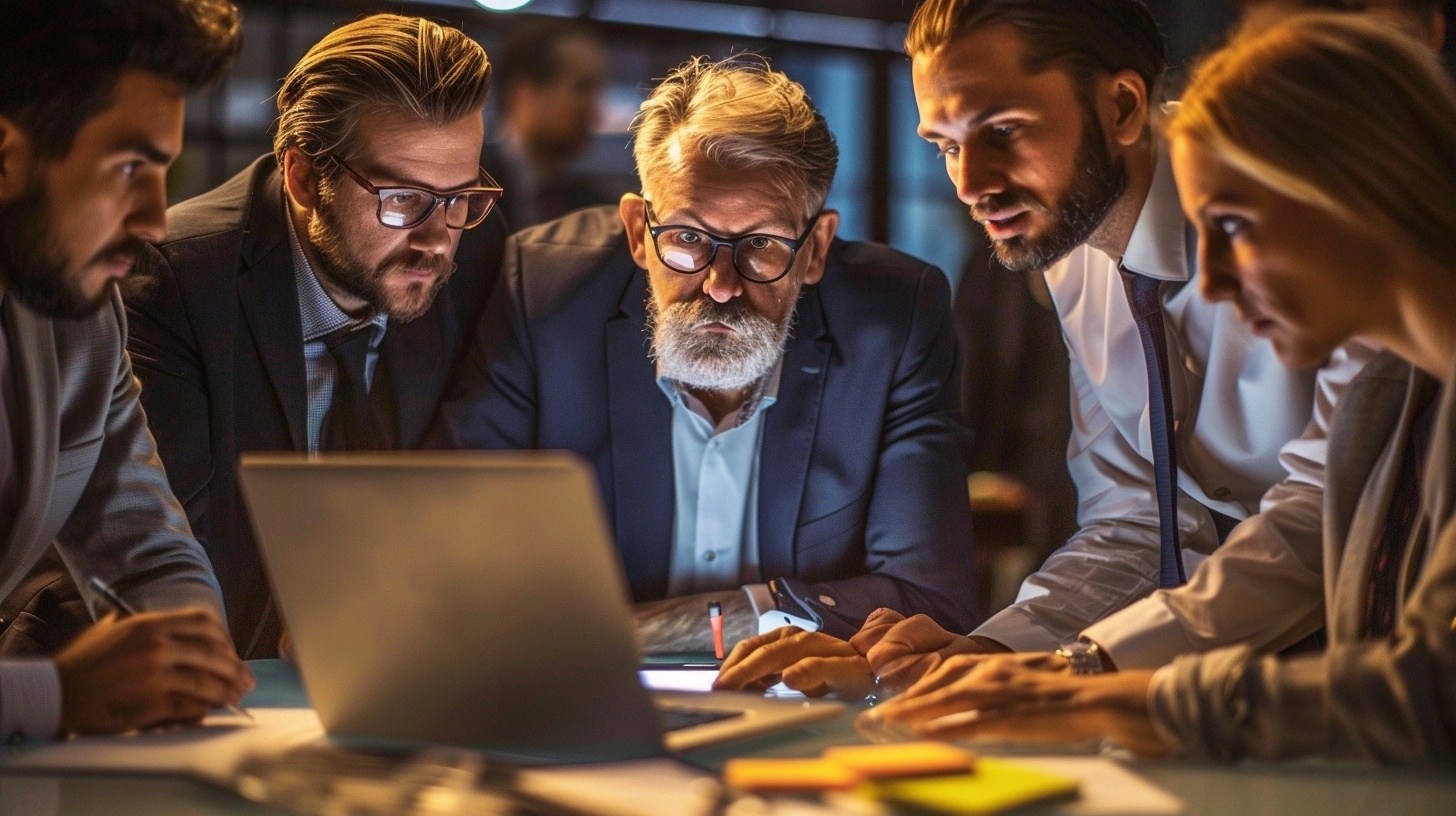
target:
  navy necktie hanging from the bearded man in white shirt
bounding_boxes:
[1123,268,1188,589]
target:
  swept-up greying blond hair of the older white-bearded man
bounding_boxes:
[632,55,839,216]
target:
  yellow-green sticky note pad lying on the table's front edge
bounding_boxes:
[865,758,1077,816]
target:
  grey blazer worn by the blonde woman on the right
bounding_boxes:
[1149,353,1456,765]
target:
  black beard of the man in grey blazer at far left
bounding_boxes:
[0,178,135,319]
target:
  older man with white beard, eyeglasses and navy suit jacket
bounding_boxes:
[431,58,974,651]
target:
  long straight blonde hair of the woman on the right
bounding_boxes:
[1168,13,1456,264]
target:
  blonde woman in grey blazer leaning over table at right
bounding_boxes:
[866,15,1456,764]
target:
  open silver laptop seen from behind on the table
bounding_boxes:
[242,452,843,761]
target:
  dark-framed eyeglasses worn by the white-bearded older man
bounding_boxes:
[644,201,818,283]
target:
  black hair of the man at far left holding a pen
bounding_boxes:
[0,0,242,159]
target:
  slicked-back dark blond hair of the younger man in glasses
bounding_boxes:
[274,15,491,163]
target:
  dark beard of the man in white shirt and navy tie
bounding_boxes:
[971,115,1127,272]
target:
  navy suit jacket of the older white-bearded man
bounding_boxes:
[431,207,974,637]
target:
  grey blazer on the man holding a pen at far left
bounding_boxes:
[0,293,223,615]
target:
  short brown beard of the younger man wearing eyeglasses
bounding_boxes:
[307,201,456,323]
